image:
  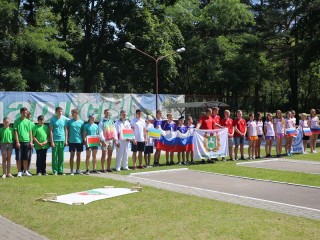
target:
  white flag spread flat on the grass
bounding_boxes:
[50,188,138,205]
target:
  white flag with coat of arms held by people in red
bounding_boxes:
[193,128,229,159]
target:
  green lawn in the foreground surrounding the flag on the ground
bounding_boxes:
[0,175,320,240]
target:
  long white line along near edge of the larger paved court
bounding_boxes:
[132,176,320,213]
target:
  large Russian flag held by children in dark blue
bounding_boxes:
[157,132,193,152]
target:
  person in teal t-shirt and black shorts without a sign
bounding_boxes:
[67,109,84,175]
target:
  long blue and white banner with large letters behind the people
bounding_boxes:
[0,92,185,123]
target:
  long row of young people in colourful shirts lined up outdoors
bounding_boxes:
[0,107,320,178]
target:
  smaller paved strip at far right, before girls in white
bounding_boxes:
[237,159,320,174]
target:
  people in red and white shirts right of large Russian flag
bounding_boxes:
[197,108,320,161]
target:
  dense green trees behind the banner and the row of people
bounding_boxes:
[0,0,320,111]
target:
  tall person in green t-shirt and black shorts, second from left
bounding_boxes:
[13,107,33,177]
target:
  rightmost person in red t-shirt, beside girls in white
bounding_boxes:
[233,110,247,161]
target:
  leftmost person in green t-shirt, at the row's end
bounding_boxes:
[0,117,14,178]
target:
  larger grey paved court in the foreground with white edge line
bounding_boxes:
[123,169,320,219]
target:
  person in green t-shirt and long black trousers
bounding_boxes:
[32,115,50,176]
